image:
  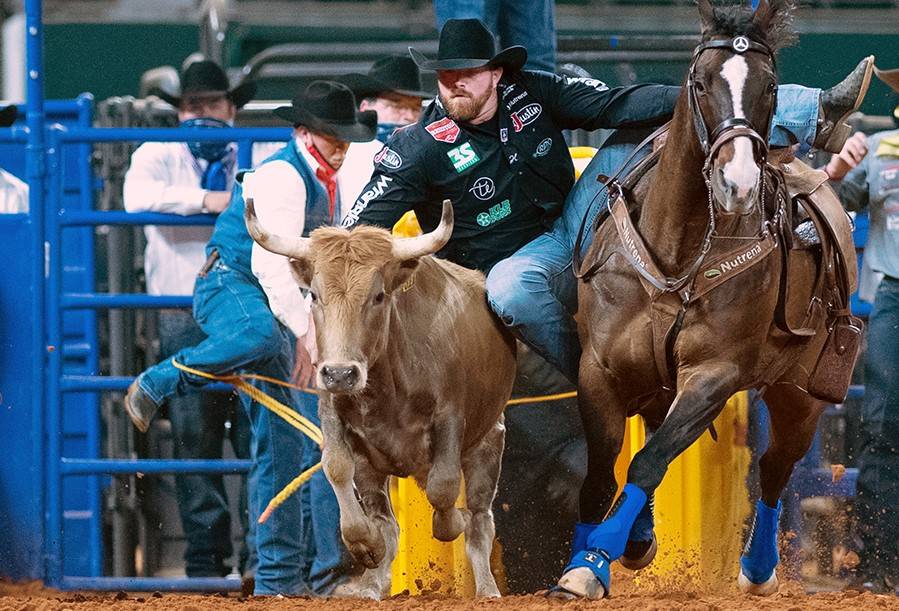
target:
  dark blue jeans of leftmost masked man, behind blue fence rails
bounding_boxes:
[159,310,252,577]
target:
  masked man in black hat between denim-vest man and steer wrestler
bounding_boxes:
[340,55,433,204]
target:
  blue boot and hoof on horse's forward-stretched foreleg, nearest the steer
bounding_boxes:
[559,484,646,598]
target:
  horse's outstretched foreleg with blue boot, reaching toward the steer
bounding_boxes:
[559,364,737,598]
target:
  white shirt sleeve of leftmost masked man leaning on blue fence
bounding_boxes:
[123,142,206,215]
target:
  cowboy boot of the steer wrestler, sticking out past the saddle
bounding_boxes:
[812,55,874,153]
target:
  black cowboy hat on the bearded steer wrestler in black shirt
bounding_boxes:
[409,19,528,70]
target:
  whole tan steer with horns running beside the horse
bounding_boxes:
[245,199,515,598]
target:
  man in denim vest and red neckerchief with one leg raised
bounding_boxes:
[125,81,376,595]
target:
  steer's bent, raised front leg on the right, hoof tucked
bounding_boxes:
[425,407,468,541]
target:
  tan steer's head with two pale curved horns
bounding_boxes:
[244,199,453,393]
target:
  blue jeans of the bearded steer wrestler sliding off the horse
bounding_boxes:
[487,85,821,384]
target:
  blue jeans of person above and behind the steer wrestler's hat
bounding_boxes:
[434,0,556,72]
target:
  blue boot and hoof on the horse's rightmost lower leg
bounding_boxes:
[738,500,781,596]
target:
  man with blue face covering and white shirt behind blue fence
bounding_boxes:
[124,61,256,577]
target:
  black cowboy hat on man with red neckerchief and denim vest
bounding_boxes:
[274,81,378,142]
